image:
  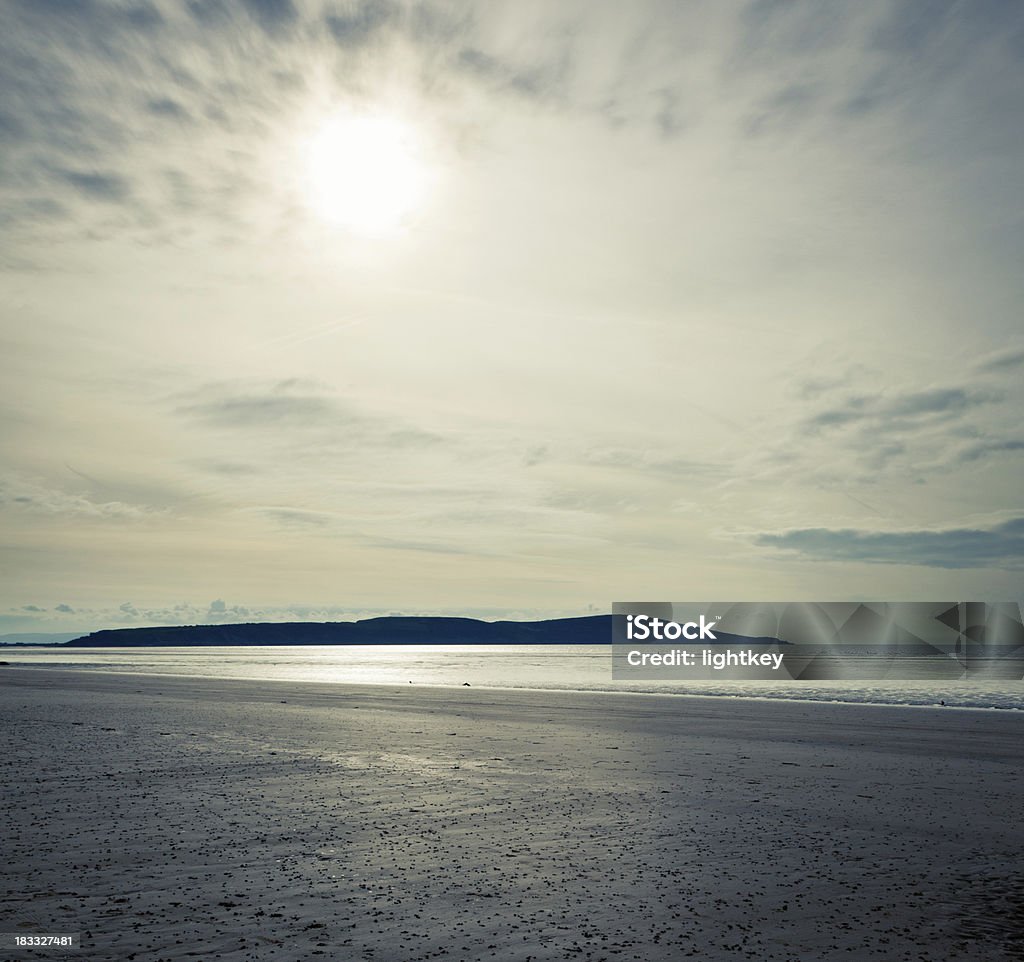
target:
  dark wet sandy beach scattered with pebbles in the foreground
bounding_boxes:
[0,668,1024,962]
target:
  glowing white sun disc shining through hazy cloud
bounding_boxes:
[307,114,427,235]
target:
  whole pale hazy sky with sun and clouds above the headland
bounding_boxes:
[0,0,1024,632]
